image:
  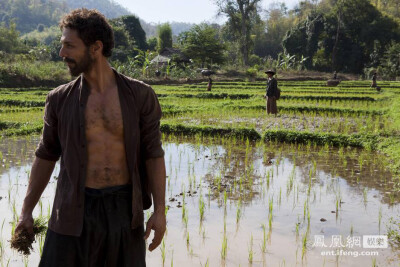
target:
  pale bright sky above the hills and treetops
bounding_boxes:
[114,0,299,23]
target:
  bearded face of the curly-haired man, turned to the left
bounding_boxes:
[59,28,93,76]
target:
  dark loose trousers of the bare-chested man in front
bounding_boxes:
[39,185,146,267]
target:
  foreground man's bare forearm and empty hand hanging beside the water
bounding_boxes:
[145,157,167,251]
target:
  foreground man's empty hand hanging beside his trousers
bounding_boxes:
[144,210,167,251]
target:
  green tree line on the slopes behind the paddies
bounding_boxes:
[0,0,400,78]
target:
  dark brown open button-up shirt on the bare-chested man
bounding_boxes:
[35,70,164,236]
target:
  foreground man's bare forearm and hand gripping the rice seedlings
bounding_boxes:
[15,157,56,234]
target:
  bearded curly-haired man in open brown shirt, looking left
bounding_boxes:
[16,9,166,267]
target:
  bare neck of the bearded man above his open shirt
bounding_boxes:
[83,59,116,94]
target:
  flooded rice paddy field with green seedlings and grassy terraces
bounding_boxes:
[0,81,400,266]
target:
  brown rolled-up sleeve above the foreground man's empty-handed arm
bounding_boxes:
[139,86,164,159]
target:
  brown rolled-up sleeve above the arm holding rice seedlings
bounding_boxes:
[35,92,61,161]
